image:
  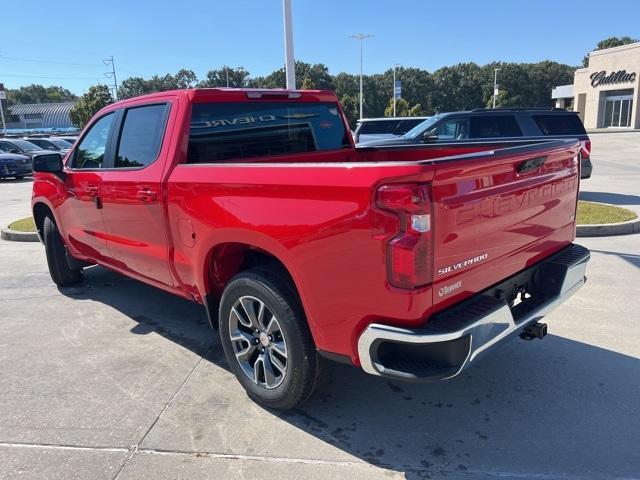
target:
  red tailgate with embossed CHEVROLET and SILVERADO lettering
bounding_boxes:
[432,140,580,311]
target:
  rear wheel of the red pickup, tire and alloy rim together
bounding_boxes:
[219,269,321,410]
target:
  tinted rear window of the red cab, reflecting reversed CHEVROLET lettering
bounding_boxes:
[187,102,350,163]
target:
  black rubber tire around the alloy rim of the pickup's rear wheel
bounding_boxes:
[218,268,323,410]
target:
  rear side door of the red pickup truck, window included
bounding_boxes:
[101,102,173,286]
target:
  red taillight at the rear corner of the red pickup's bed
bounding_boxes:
[376,184,433,288]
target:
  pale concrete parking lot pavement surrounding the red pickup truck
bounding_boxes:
[0,133,640,480]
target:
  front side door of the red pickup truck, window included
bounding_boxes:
[57,113,115,260]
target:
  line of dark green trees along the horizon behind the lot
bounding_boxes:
[2,37,637,127]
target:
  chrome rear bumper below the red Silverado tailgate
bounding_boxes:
[358,245,589,381]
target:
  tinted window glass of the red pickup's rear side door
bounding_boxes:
[115,104,168,168]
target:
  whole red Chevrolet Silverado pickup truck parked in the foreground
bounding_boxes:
[32,89,589,409]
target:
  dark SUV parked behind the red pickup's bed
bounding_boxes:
[360,108,593,178]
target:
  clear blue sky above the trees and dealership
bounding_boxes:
[0,0,640,93]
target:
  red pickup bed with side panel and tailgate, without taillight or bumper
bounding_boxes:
[168,137,580,362]
